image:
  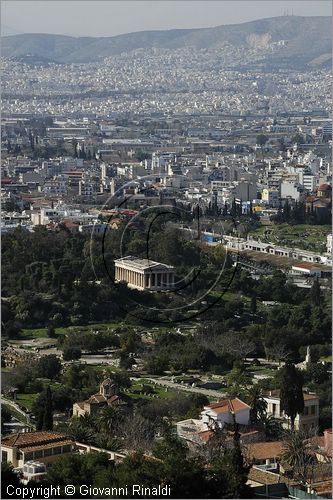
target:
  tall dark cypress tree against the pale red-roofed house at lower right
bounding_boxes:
[279,361,304,431]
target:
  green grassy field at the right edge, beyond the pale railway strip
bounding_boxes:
[249,224,332,252]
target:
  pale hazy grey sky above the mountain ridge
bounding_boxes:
[1,0,332,36]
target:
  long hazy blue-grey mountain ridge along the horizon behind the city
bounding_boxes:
[1,16,332,67]
